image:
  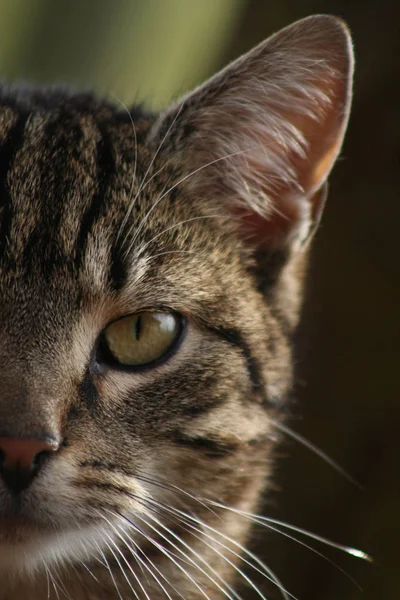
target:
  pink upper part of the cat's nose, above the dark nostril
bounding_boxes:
[0,437,58,469]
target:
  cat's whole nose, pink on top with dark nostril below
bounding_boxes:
[0,437,60,493]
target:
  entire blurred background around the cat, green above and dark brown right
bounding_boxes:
[0,0,400,600]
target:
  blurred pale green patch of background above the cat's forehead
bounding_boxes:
[0,0,246,107]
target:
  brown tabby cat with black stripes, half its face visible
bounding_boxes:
[0,15,353,600]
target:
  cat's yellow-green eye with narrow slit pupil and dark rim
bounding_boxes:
[100,311,182,368]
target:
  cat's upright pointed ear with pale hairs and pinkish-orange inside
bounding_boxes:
[149,15,353,250]
